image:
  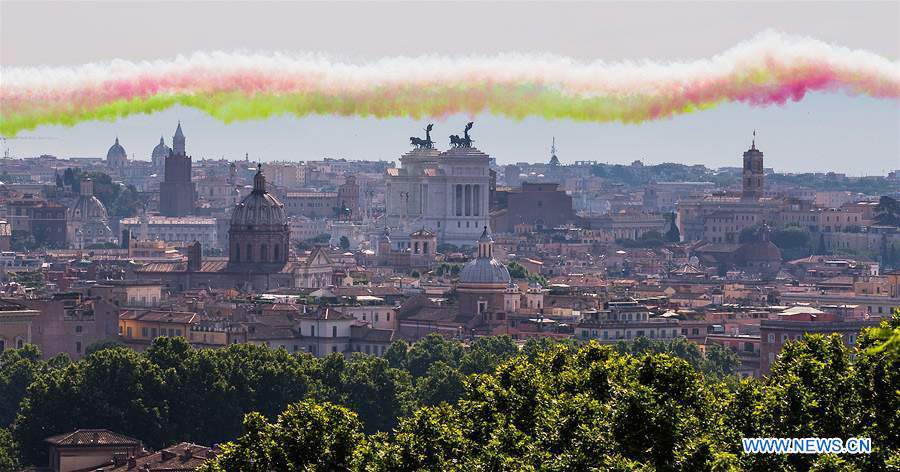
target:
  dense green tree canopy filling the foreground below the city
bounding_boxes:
[0,315,900,472]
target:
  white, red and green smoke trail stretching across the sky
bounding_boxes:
[0,32,900,136]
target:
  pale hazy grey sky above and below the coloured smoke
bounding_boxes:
[0,0,900,175]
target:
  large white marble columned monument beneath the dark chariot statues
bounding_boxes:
[385,147,490,249]
